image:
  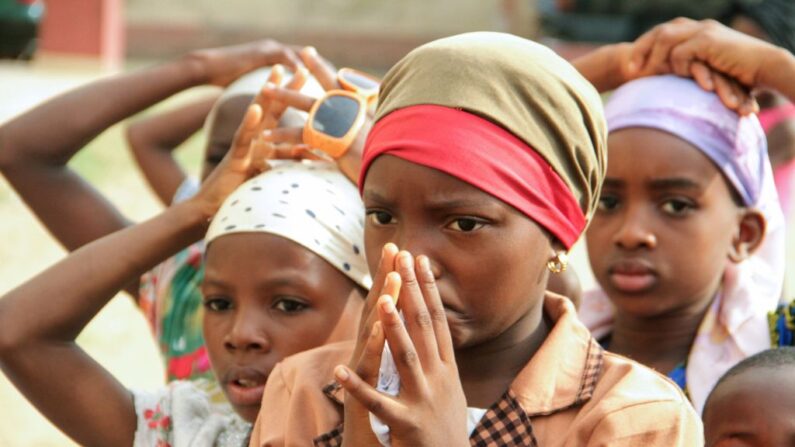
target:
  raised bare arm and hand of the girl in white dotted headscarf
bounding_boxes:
[0,101,274,446]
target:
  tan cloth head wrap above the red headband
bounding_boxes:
[376,32,607,226]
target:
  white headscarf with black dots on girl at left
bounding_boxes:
[205,161,372,289]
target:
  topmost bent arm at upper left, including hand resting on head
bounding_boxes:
[0,40,300,296]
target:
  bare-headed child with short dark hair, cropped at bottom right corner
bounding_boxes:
[704,347,795,447]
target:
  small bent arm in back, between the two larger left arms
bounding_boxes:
[126,93,220,206]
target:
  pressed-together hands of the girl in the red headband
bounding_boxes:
[335,251,469,447]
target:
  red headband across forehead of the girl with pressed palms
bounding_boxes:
[359,105,585,249]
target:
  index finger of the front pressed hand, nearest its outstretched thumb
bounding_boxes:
[377,295,427,394]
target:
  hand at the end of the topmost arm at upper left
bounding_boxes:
[188,39,302,87]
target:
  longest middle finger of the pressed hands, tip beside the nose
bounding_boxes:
[396,251,439,370]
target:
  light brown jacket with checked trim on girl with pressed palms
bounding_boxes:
[250,294,703,447]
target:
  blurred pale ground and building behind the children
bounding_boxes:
[0,0,795,446]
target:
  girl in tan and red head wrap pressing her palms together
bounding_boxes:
[251,33,702,446]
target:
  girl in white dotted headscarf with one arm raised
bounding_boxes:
[0,93,370,446]
